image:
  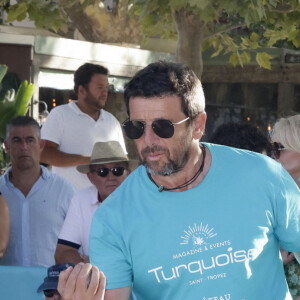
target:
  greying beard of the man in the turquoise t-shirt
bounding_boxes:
[141,141,190,176]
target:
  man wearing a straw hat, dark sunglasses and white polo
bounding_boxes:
[55,141,137,264]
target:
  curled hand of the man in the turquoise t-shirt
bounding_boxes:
[57,263,106,300]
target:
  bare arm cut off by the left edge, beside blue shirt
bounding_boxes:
[0,194,10,259]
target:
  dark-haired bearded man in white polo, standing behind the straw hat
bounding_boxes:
[41,63,126,189]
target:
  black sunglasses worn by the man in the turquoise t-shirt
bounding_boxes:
[122,117,189,140]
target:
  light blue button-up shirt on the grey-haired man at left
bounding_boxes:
[0,166,74,267]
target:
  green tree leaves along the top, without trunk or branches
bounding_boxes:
[1,0,300,68]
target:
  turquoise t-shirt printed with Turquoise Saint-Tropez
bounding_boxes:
[90,144,300,300]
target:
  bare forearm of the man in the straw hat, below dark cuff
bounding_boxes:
[54,244,90,265]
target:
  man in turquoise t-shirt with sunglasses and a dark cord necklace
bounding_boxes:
[56,62,300,300]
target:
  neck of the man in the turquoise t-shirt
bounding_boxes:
[150,144,211,191]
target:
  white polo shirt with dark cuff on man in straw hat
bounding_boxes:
[58,186,100,256]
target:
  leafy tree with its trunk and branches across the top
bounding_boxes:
[0,0,300,77]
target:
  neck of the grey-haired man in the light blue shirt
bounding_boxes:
[9,165,42,196]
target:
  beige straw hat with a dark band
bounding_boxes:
[76,141,138,174]
